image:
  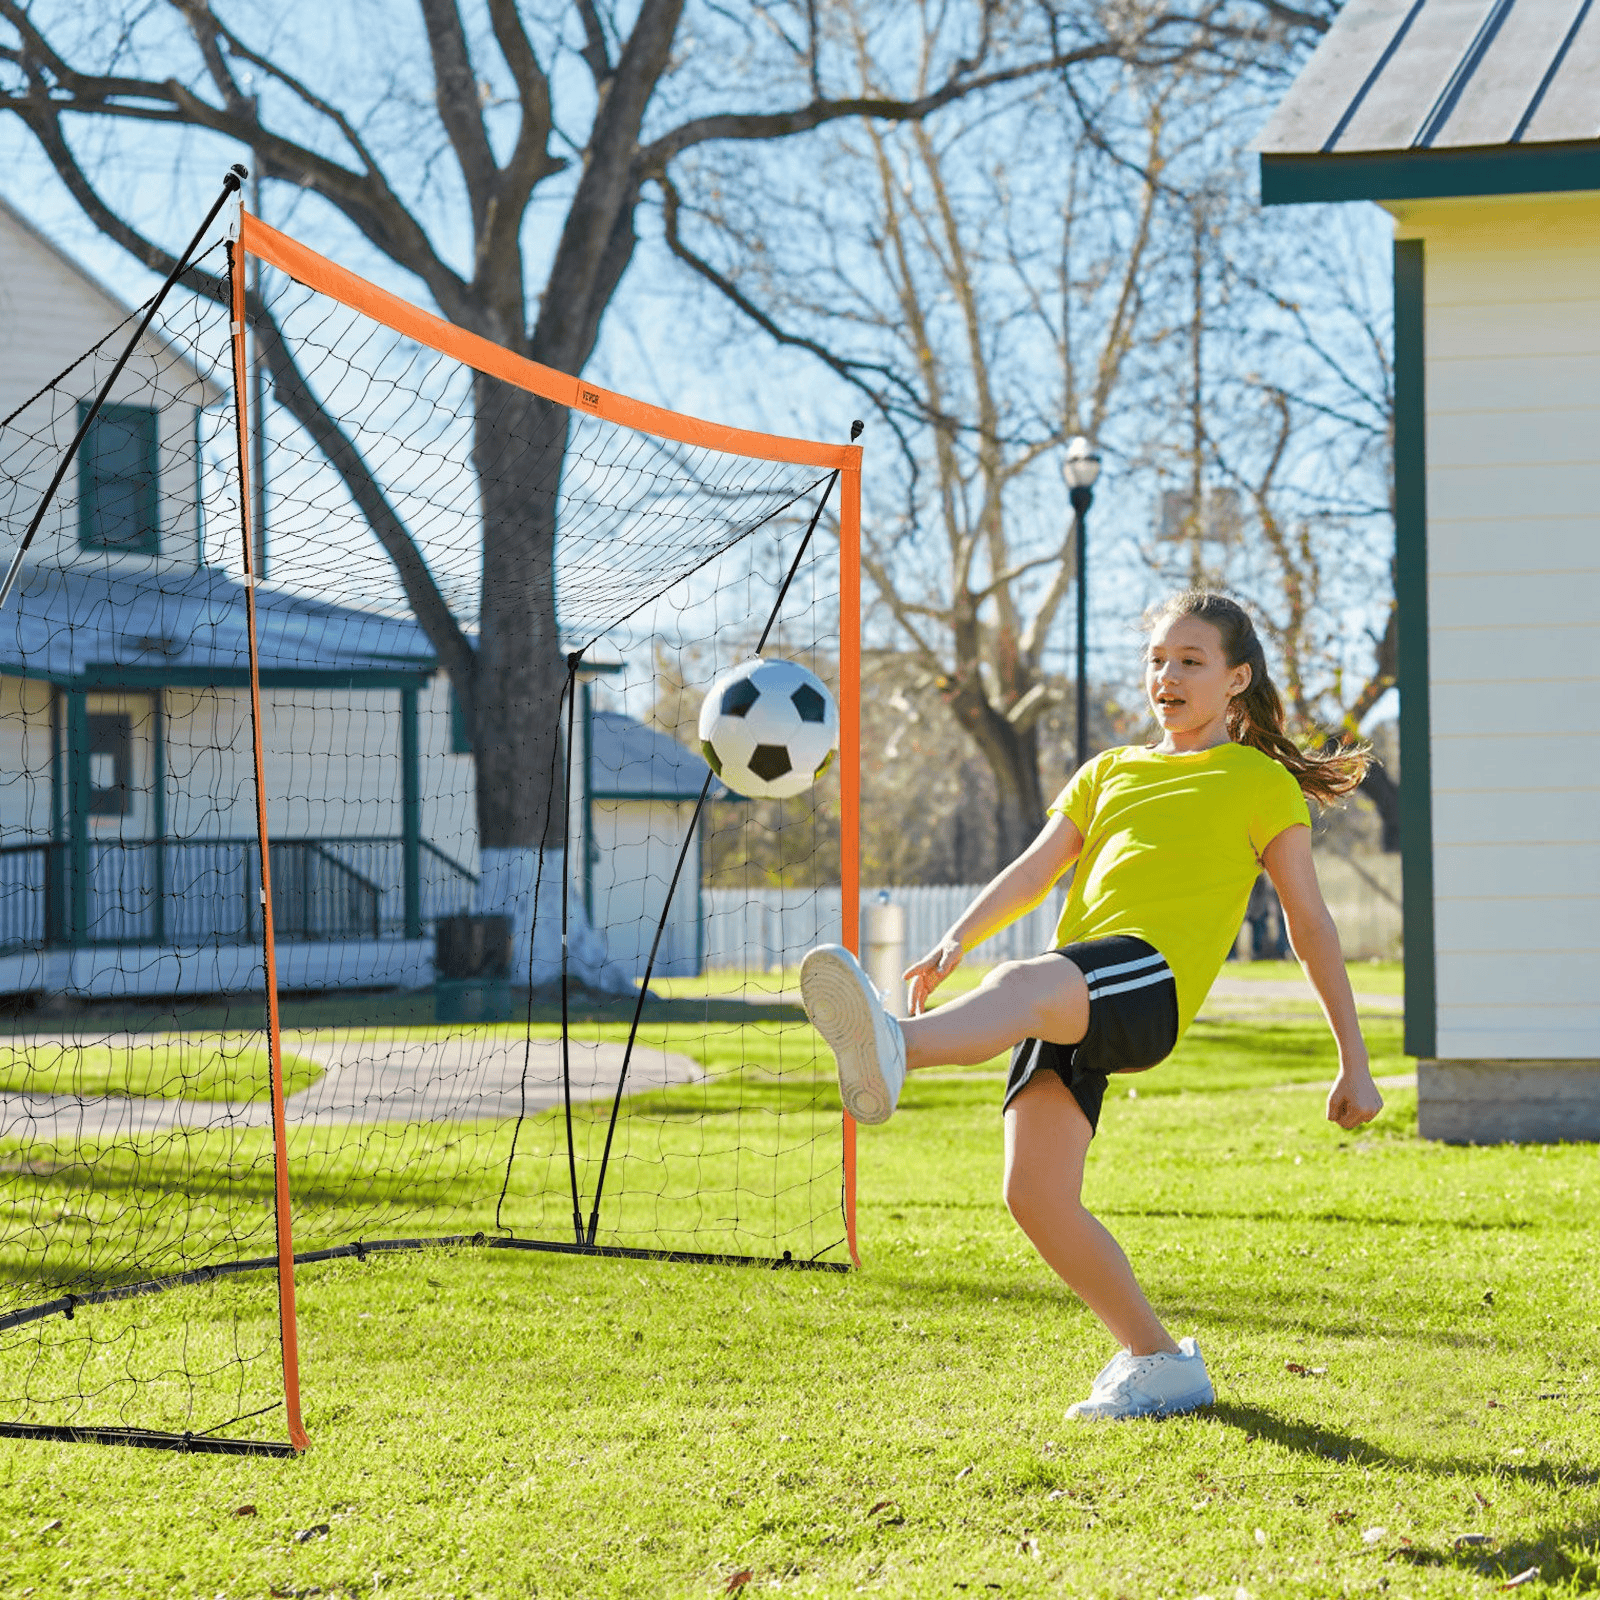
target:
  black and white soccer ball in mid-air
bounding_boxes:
[699,659,838,800]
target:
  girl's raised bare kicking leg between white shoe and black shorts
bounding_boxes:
[901,955,1090,1069]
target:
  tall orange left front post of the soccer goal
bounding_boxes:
[227,219,310,1450]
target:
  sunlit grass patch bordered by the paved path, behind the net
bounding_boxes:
[0,1034,323,1101]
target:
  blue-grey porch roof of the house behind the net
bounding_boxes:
[0,566,435,688]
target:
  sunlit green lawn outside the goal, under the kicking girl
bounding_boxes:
[0,1019,1600,1600]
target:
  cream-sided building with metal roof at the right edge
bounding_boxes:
[1258,0,1600,1139]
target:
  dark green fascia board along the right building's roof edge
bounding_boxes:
[1261,142,1600,205]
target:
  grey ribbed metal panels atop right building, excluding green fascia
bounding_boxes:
[1254,0,1600,158]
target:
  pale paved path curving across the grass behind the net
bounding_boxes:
[0,1032,704,1141]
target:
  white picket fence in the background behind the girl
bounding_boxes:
[701,851,1400,971]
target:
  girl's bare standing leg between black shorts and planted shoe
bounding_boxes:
[1005,1068,1178,1355]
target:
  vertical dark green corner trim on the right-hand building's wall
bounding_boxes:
[1395,238,1438,1056]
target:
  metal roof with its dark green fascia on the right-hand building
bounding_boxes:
[1254,0,1600,205]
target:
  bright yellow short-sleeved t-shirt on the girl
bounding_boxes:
[1050,744,1310,1038]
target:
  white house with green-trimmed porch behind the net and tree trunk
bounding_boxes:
[0,202,706,995]
